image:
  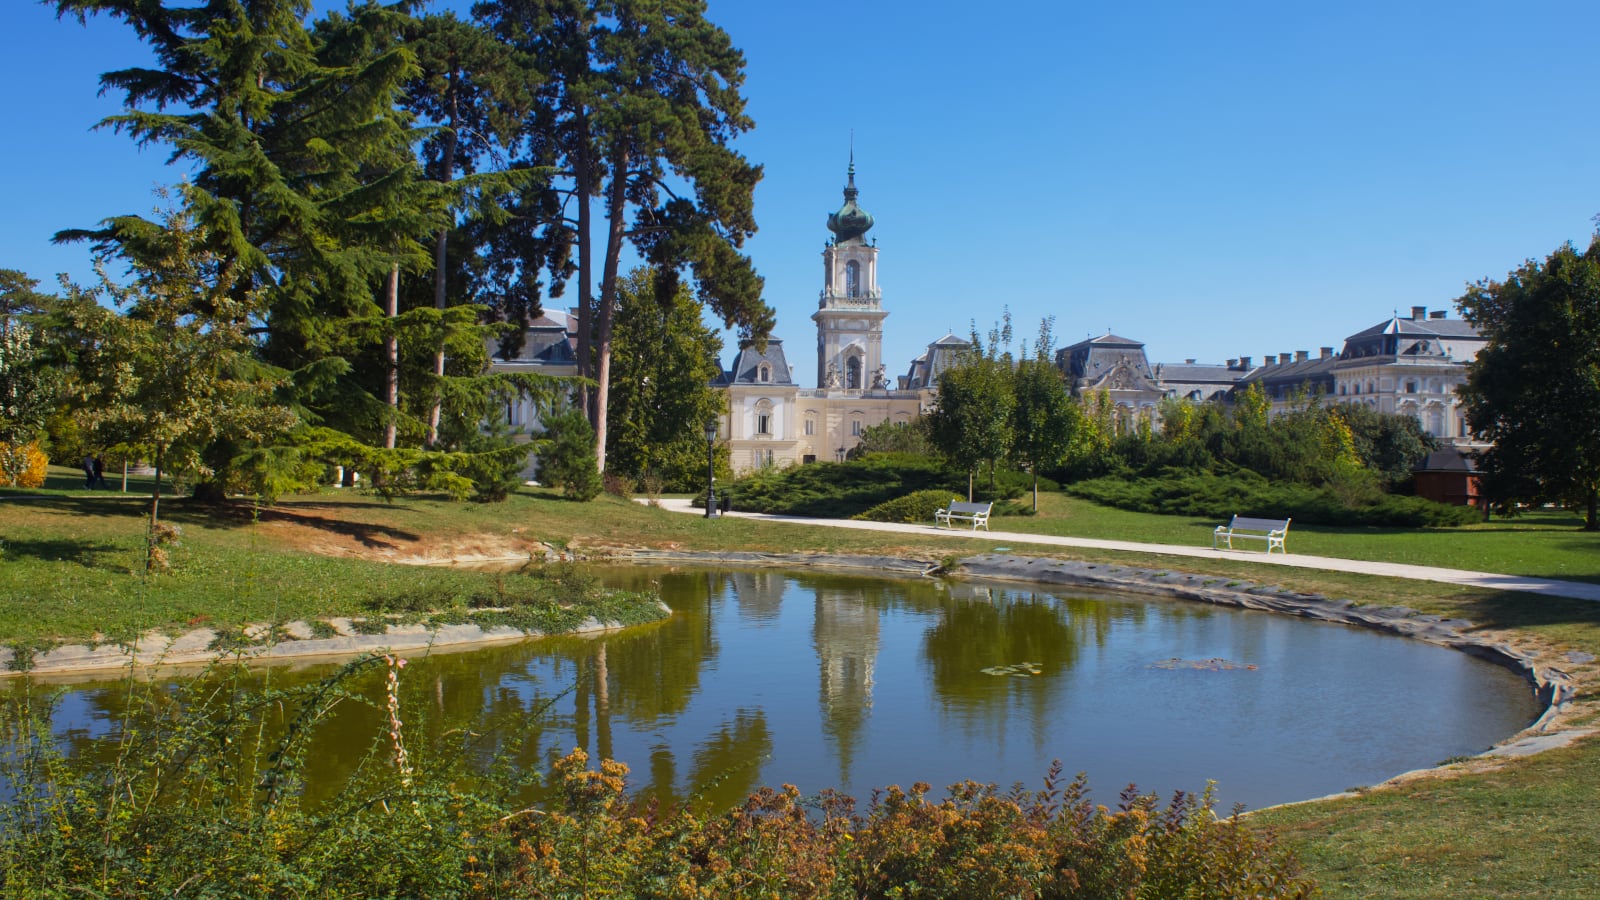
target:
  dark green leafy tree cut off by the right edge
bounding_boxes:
[1458,235,1600,532]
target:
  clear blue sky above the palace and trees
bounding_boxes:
[0,0,1600,386]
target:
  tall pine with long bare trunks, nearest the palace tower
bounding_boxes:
[475,0,773,468]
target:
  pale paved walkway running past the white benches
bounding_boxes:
[646,500,1600,602]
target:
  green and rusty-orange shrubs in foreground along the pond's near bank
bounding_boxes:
[0,657,1312,898]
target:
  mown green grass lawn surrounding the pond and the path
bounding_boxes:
[9,469,1600,897]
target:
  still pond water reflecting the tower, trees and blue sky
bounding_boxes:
[12,567,1539,809]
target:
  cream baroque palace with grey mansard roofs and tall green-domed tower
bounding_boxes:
[491,160,1483,472]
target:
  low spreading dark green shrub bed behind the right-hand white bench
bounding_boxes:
[1064,471,1483,527]
